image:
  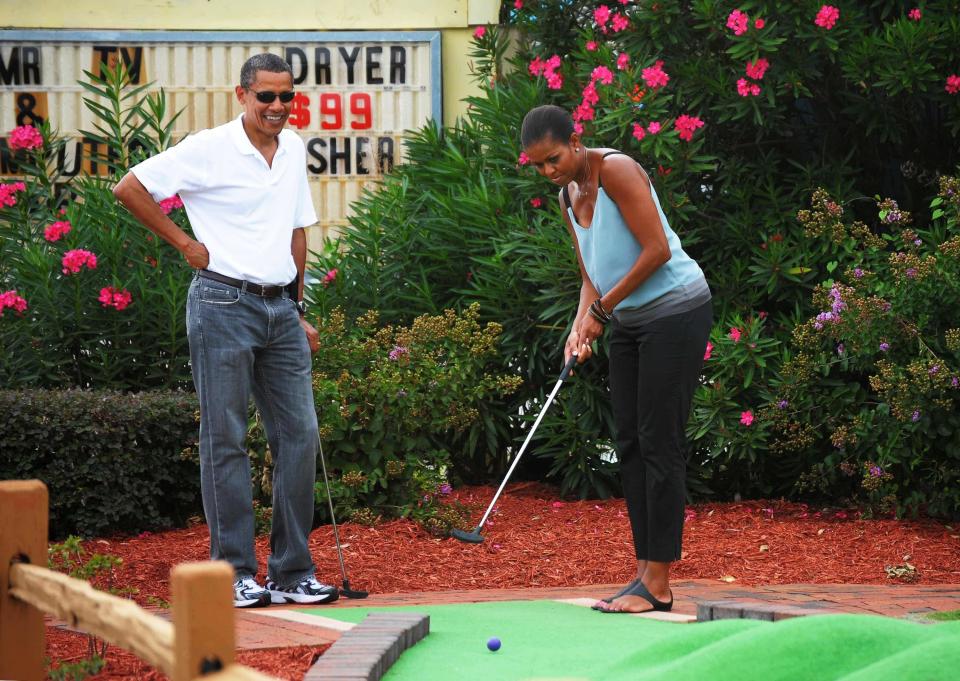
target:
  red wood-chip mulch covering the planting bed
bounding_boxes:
[47,483,960,679]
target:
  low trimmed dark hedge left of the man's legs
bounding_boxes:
[0,390,200,538]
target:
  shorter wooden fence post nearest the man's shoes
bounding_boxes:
[170,561,236,681]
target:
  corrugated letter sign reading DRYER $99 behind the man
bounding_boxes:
[0,31,440,248]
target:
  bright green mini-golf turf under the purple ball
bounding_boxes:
[302,601,960,681]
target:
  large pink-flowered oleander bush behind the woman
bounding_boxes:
[312,0,960,512]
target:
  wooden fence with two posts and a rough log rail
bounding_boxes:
[0,480,271,681]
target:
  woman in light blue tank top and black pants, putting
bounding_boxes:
[520,105,713,612]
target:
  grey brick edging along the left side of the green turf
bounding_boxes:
[303,612,430,681]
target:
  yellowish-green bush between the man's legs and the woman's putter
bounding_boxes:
[314,305,520,531]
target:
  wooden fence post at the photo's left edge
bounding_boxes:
[0,480,49,681]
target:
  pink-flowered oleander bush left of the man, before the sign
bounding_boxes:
[0,69,191,390]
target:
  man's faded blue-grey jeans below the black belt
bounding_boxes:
[187,276,317,587]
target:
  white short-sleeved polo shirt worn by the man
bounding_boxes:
[131,114,317,284]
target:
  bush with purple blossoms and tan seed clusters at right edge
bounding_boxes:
[765,177,960,516]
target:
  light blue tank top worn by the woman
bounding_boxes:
[564,159,706,311]
